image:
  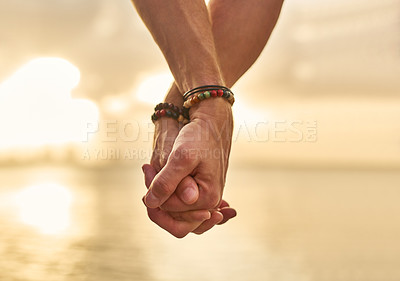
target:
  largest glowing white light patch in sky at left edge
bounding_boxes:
[0,58,99,149]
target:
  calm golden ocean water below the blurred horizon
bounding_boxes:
[0,166,400,281]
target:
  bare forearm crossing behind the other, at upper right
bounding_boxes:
[209,0,283,87]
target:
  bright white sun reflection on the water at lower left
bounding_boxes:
[16,184,72,234]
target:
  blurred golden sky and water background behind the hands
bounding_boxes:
[0,0,400,281]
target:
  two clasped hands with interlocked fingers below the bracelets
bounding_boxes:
[143,98,236,238]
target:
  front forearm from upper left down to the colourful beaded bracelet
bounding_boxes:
[132,0,224,92]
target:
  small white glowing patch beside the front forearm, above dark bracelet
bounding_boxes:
[136,73,174,105]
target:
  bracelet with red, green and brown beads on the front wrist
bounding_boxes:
[183,86,235,112]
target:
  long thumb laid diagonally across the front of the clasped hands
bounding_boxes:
[145,153,193,208]
